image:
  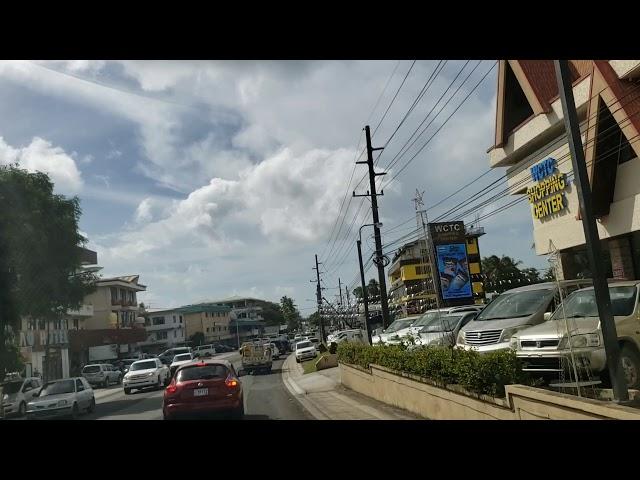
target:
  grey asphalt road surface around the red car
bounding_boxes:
[80,353,312,420]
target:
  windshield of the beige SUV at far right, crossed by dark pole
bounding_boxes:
[551,287,637,321]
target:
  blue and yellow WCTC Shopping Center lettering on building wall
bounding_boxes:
[527,158,567,219]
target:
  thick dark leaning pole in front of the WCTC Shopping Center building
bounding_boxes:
[554,60,629,402]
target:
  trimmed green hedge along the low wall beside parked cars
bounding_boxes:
[338,342,535,397]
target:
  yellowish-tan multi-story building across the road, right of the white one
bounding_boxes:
[176,303,235,343]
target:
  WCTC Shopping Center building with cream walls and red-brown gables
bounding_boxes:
[488,60,640,279]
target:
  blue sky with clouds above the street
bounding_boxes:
[0,60,547,316]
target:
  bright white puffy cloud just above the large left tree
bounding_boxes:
[0,137,83,194]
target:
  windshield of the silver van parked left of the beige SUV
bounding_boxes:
[474,289,553,322]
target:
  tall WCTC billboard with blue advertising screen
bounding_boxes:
[429,222,473,305]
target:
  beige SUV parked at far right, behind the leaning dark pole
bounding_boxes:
[510,281,640,389]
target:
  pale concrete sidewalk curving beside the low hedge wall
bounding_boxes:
[282,355,421,420]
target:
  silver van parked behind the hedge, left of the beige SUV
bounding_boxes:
[456,279,592,353]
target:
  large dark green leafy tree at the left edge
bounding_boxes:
[0,165,97,375]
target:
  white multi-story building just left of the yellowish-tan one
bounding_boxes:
[138,309,185,353]
